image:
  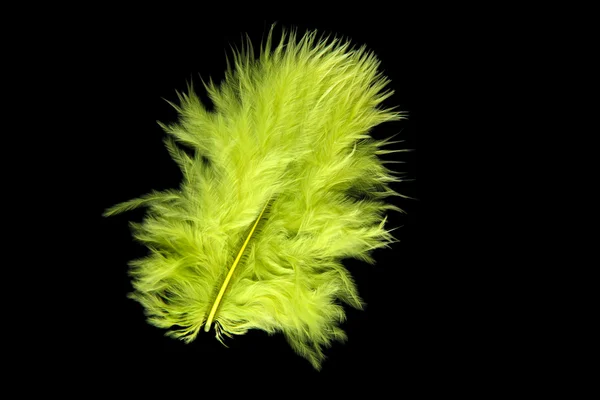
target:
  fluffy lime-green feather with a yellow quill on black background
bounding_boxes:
[105,29,410,369]
